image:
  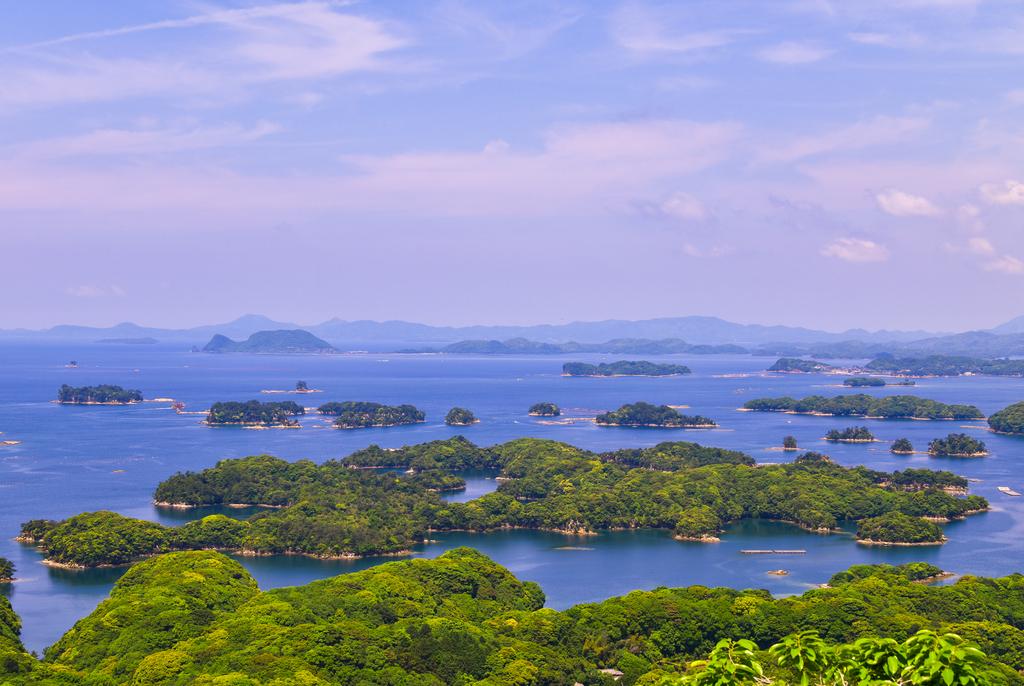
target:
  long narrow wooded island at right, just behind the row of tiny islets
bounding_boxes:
[742,393,985,420]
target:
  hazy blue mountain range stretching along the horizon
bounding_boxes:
[0,314,1024,357]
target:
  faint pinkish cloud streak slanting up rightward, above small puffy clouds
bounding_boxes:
[760,116,931,162]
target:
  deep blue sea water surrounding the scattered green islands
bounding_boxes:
[0,344,1024,651]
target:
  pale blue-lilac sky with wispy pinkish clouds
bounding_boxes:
[0,0,1024,331]
